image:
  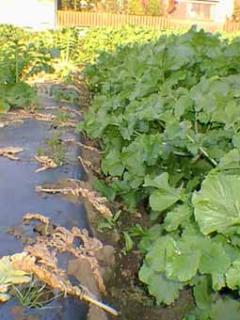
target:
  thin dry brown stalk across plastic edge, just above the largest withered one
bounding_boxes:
[35,183,112,218]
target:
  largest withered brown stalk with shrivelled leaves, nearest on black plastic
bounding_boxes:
[11,213,118,316]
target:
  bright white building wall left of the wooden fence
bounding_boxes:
[0,0,57,30]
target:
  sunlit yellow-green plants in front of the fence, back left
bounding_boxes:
[0,25,165,112]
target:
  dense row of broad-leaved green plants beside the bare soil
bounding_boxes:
[79,29,240,320]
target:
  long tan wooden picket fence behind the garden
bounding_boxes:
[57,11,240,32]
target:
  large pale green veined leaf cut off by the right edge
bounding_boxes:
[192,174,240,235]
